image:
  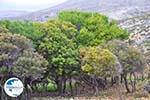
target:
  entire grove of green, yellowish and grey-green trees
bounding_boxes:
[0,11,149,100]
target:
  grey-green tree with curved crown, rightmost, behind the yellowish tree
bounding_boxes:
[103,40,146,92]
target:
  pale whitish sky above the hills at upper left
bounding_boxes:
[0,0,67,11]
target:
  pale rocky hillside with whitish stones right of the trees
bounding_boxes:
[119,15,150,66]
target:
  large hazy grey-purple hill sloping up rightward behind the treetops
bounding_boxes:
[1,0,150,21]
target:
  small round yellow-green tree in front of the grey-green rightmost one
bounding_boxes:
[80,46,121,93]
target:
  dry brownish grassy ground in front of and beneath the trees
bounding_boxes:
[31,79,150,100]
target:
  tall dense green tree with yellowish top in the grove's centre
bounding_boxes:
[38,20,79,95]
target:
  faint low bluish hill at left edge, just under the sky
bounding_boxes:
[0,10,29,19]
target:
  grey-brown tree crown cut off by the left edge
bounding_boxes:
[0,33,31,72]
